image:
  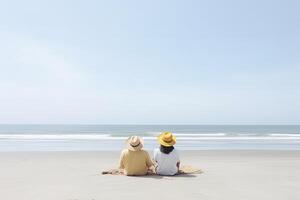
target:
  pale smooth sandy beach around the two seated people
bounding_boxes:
[0,151,300,200]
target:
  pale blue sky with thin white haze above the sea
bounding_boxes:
[0,0,300,124]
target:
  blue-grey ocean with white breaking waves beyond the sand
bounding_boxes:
[0,125,300,151]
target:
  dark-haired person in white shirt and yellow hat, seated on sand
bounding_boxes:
[153,132,180,176]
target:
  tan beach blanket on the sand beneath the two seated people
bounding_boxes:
[102,165,203,175]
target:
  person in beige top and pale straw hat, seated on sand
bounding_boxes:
[119,136,153,176]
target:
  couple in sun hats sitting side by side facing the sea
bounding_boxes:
[119,132,180,176]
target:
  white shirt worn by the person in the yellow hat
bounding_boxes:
[153,148,180,175]
